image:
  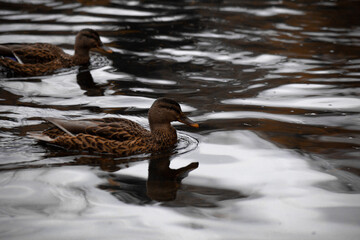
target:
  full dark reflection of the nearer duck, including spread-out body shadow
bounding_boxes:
[99,156,247,208]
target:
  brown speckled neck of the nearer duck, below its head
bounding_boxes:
[150,123,177,147]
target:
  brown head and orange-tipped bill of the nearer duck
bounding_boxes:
[148,98,199,131]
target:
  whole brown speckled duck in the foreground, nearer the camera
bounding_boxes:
[29,98,199,156]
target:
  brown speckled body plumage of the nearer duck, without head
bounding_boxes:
[43,118,169,156]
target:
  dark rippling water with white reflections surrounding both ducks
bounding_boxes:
[0,0,360,239]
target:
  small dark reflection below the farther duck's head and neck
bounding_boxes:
[76,66,105,96]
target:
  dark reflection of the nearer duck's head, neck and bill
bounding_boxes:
[147,157,199,202]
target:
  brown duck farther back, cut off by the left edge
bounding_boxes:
[0,28,111,76]
